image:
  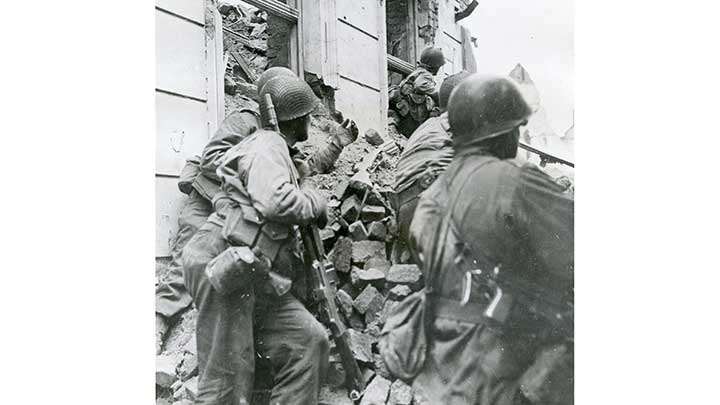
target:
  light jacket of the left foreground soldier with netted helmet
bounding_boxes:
[210,130,326,276]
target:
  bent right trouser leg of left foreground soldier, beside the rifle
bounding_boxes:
[256,294,330,405]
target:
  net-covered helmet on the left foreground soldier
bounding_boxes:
[259,75,320,123]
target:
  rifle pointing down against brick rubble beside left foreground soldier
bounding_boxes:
[300,225,365,401]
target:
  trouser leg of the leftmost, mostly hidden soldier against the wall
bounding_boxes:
[155,190,212,318]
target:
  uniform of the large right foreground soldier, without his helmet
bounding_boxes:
[410,145,574,405]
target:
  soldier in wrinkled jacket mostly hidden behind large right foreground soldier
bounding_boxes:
[393,70,470,262]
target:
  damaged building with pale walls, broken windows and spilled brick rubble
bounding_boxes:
[155,0,484,404]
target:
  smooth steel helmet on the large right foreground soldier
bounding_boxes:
[447,74,532,143]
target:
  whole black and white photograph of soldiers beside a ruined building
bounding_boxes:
[155,0,575,405]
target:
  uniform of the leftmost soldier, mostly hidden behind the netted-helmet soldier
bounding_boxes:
[155,109,343,318]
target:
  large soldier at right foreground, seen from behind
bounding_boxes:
[410,75,574,405]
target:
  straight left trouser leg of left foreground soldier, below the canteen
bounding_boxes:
[183,222,255,405]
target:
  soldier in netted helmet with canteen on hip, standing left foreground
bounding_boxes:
[182,76,329,404]
